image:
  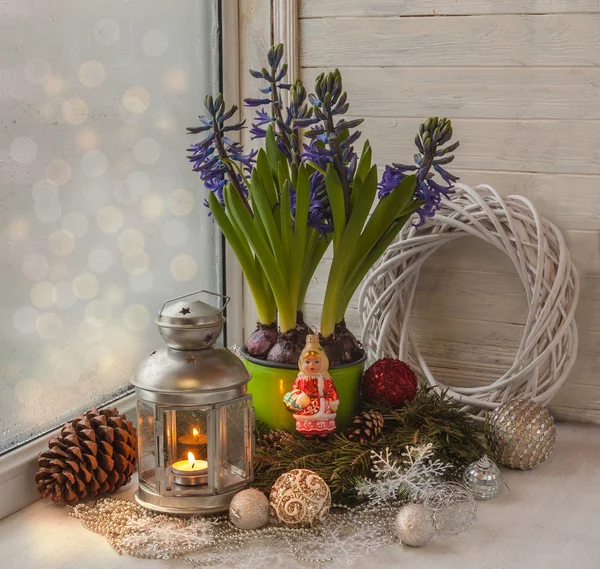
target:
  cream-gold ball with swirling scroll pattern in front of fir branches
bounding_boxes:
[269,468,331,527]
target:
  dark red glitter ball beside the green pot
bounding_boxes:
[362,358,417,409]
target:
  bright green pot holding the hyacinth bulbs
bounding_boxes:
[242,352,367,432]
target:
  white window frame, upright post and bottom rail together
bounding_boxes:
[0,0,244,520]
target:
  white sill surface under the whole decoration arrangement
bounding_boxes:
[0,424,600,569]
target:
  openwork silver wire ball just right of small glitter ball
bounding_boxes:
[425,482,477,535]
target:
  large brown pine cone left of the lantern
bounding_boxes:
[35,409,137,504]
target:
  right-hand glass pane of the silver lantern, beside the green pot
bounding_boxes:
[219,397,252,489]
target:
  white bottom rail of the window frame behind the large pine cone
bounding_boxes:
[0,393,136,520]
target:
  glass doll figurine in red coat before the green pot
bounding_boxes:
[283,334,340,437]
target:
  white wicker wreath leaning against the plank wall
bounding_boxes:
[358,184,579,421]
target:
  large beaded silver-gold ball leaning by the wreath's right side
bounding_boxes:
[485,399,556,470]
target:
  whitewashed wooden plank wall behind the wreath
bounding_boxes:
[299,0,600,423]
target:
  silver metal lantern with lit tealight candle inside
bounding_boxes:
[133,291,254,514]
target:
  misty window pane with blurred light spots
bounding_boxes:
[0,0,221,452]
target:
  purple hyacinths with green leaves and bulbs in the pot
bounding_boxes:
[188,44,459,365]
